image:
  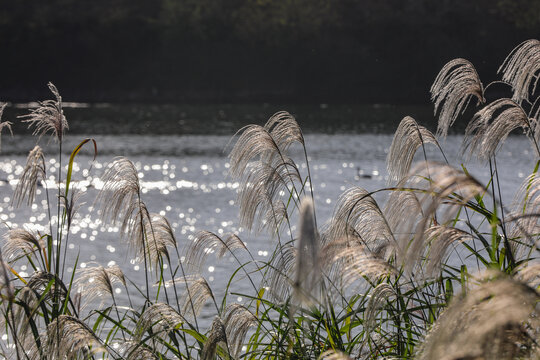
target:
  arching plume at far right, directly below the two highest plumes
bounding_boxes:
[462,99,540,160]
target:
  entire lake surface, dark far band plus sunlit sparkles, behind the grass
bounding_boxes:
[0,105,535,326]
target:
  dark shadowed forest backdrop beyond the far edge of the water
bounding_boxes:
[0,0,540,103]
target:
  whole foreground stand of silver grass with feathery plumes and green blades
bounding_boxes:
[0,40,540,360]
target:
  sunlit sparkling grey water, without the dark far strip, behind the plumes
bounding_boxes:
[0,129,534,325]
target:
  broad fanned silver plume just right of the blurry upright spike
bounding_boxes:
[326,187,394,250]
